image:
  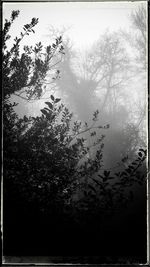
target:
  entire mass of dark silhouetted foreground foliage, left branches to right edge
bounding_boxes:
[3,11,146,262]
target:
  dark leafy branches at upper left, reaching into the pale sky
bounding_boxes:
[2,11,63,100]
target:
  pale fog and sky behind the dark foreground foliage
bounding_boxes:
[3,1,148,264]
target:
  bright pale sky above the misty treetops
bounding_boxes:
[3,1,146,49]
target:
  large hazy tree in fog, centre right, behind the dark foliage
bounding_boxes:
[50,29,143,171]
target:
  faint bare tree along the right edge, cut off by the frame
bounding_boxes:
[120,4,147,150]
